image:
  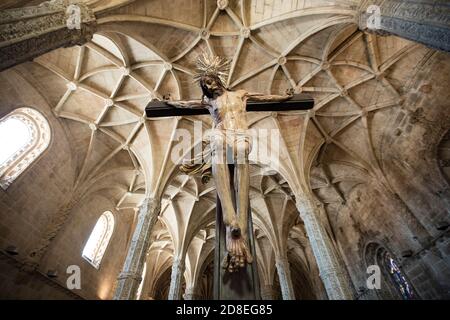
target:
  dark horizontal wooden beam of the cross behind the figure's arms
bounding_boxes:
[145,94,314,118]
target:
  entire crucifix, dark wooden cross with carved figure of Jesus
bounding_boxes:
[146,54,314,299]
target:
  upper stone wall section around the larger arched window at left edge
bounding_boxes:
[0,66,75,264]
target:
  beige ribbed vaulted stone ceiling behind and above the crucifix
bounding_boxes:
[10,0,440,298]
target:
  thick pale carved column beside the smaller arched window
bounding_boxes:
[114,198,161,300]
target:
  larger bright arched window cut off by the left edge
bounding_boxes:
[0,108,50,190]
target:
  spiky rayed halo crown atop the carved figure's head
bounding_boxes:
[194,53,230,84]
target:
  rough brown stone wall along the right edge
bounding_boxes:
[335,53,450,299]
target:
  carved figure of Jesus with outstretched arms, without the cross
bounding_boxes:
[167,55,293,272]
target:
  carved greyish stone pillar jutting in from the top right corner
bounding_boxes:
[357,0,450,51]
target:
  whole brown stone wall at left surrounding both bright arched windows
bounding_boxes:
[0,64,134,299]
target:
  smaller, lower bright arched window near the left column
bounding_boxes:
[83,211,114,269]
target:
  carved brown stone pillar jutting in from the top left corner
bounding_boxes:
[0,0,96,71]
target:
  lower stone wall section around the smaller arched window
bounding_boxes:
[41,194,134,299]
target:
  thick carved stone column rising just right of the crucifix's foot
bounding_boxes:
[296,197,353,300]
